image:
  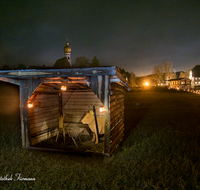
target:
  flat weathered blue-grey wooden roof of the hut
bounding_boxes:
[0,67,129,90]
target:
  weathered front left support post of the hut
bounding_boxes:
[20,80,31,147]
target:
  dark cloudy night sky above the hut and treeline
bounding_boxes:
[0,0,200,76]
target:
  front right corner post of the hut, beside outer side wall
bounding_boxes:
[104,75,110,156]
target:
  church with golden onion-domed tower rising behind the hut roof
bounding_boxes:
[53,42,72,69]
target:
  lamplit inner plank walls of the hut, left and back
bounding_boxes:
[28,83,104,145]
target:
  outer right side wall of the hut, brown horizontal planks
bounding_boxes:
[110,83,125,155]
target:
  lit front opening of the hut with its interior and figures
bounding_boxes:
[28,78,105,153]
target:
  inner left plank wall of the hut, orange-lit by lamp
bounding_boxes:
[28,84,59,145]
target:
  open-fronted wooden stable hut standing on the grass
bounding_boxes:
[0,67,129,156]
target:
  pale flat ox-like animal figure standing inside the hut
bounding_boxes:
[81,110,105,144]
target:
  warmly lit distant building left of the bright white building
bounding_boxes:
[168,78,191,90]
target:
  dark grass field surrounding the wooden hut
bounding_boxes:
[0,83,200,190]
